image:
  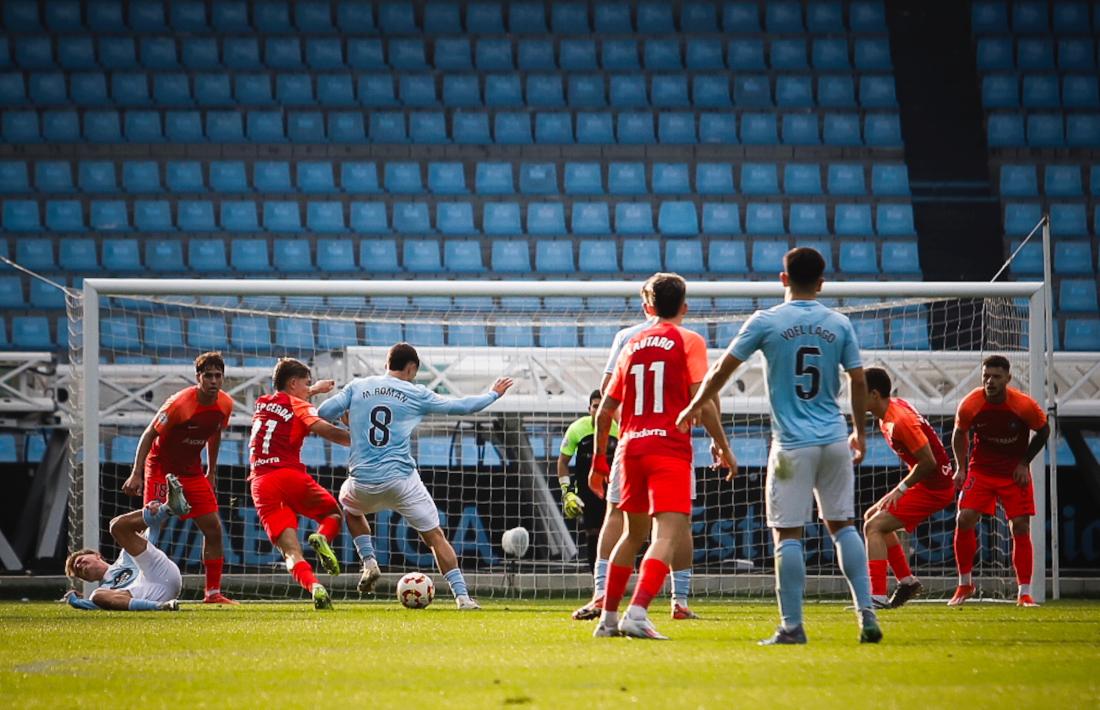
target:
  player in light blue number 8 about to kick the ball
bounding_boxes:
[317,342,513,610]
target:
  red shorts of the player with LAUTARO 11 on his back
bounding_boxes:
[618,455,692,515]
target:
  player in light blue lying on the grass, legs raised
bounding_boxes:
[65,473,189,611]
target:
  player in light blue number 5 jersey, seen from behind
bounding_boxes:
[679,247,882,645]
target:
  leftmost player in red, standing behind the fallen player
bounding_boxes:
[122,352,237,604]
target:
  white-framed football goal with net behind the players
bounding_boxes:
[69,280,1045,599]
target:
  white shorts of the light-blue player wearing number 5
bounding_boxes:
[765,441,856,527]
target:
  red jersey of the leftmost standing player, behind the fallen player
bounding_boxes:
[145,385,233,474]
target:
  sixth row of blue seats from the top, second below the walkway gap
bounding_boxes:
[2,199,919,237]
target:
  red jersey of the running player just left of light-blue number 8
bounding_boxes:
[249,392,321,477]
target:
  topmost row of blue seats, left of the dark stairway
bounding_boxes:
[2,0,888,35]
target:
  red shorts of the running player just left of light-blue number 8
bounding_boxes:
[249,469,340,543]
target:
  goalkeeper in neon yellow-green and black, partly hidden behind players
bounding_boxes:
[558,390,618,569]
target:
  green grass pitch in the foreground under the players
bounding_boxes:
[0,599,1100,710]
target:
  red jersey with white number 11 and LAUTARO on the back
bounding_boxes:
[607,321,707,461]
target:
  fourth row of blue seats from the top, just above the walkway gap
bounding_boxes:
[0,109,902,148]
